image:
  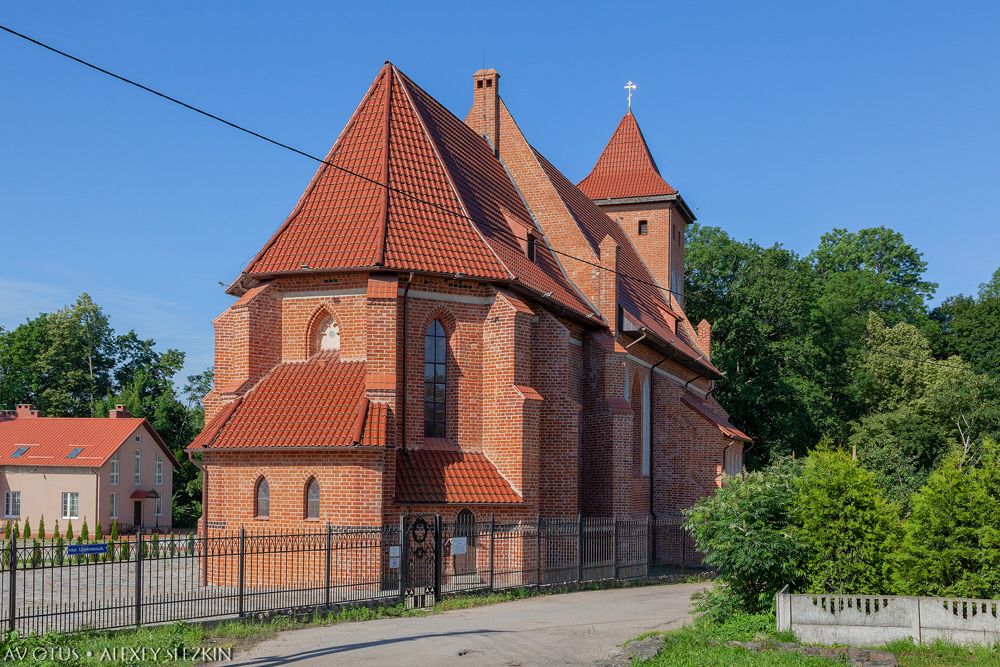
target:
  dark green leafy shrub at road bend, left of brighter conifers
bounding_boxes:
[685,462,805,619]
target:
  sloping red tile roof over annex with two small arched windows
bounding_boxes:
[189,352,386,450]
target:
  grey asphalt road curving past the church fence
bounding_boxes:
[230,584,706,667]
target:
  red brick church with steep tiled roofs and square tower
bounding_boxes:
[189,63,749,531]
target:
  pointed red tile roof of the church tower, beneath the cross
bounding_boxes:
[577,111,677,199]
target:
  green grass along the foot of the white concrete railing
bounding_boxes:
[636,614,1000,667]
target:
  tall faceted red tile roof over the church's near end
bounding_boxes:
[238,63,593,315]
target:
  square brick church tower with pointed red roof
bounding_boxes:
[577,108,695,306]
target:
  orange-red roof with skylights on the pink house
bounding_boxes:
[0,413,177,468]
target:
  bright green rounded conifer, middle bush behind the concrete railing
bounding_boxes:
[795,446,900,594]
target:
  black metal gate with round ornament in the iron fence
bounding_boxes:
[400,516,441,609]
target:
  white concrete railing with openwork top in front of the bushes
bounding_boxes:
[775,586,1000,646]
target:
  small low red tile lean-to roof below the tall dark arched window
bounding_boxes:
[396,449,521,504]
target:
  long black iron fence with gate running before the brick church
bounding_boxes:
[0,515,700,634]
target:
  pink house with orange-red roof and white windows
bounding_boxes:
[0,405,178,535]
